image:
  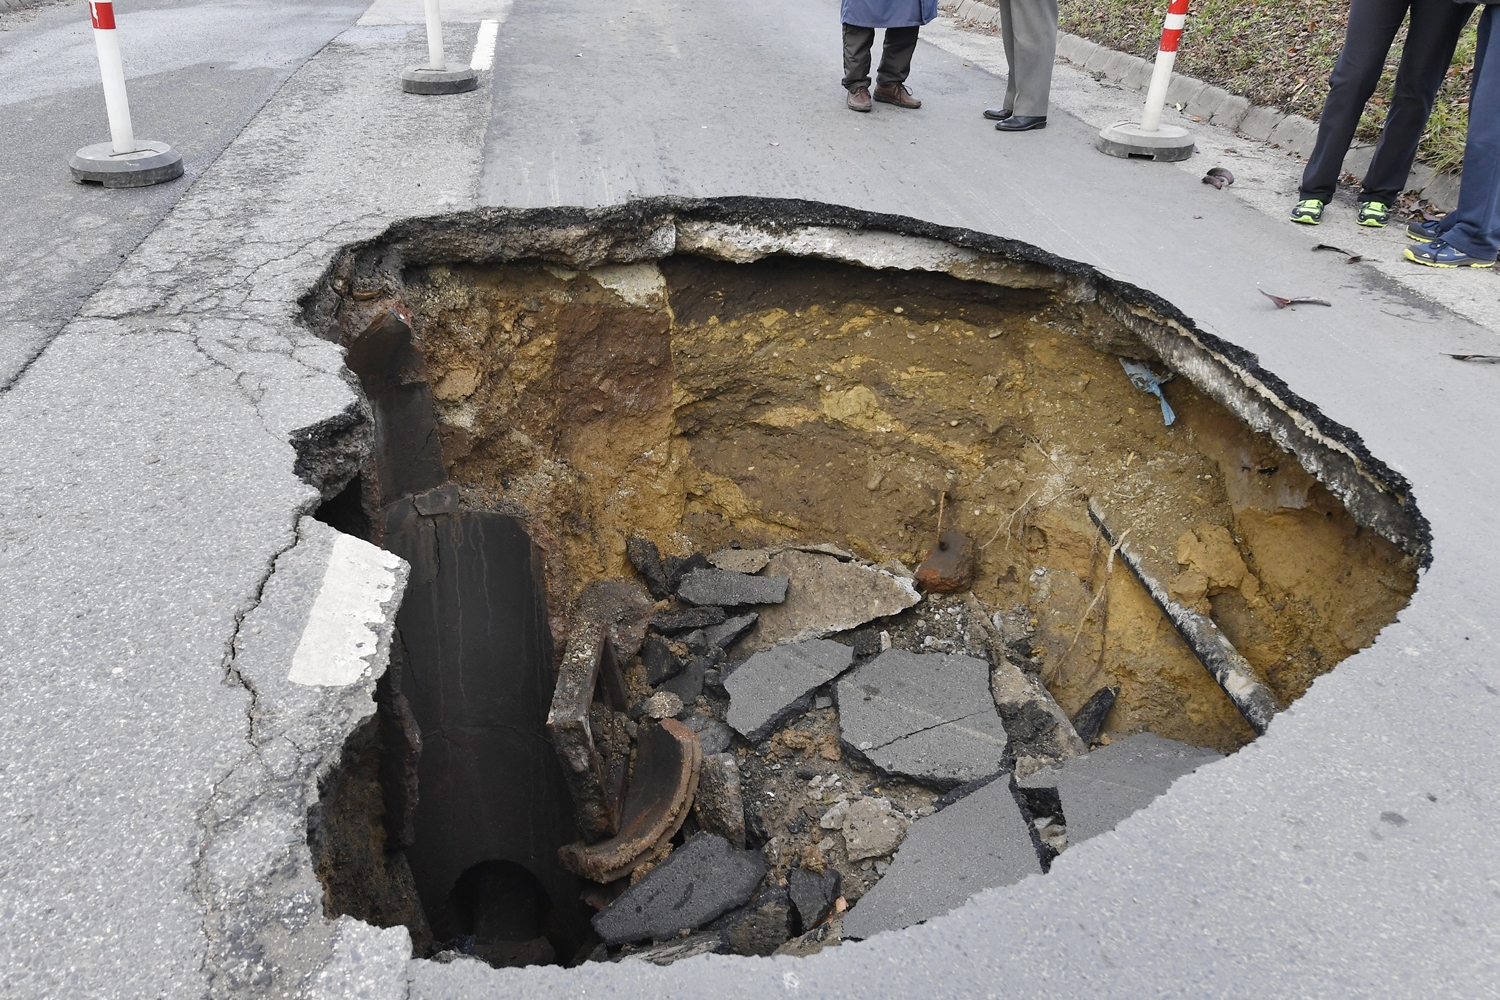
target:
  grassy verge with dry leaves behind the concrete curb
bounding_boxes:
[1059,0,1481,169]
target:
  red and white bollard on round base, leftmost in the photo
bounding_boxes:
[68,0,183,187]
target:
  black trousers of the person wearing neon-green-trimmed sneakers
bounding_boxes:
[1302,0,1475,202]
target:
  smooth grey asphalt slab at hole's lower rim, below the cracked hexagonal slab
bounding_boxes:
[843,778,1041,939]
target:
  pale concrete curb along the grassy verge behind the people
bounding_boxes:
[942,0,1463,211]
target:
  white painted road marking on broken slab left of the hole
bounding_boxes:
[287,535,401,687]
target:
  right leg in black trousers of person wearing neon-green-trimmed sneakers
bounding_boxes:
[1359,0,1475,205]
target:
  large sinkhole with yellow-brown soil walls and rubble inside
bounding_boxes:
[309,209,1425,966]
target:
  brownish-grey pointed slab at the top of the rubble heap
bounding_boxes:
[749,549,921,649]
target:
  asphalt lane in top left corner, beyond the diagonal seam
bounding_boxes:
[0,0,365,390]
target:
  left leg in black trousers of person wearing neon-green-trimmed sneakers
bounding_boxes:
[1298,0,1404,202]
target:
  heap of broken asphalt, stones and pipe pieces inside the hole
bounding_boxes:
[548,531,1218,964]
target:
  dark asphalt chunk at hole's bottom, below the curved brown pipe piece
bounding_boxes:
[594,834,765,945]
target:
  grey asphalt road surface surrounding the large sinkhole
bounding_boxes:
[0,0,1500,1000]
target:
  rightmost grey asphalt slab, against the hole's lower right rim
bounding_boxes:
[1020,733,1223,844]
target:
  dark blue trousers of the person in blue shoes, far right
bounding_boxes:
[1439,4,1500,261]
